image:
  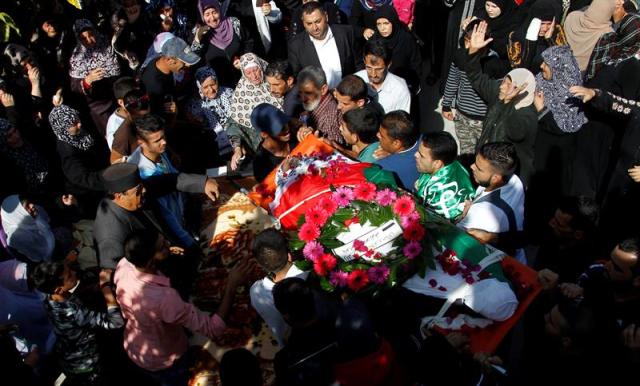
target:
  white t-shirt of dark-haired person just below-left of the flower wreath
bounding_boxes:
[249,264,309,347]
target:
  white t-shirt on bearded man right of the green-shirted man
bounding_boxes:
[458,174,526,264]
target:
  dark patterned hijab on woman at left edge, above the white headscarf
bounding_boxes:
[0,118,49,191]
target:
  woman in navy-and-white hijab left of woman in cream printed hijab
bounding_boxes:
[191,66,233,157]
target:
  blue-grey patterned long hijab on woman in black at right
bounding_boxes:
[536,46,587,133]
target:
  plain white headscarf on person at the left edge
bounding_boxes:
[0,194,56,262]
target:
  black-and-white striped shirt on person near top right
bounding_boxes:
[442,63,487,120]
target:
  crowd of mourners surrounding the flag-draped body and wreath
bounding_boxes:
[0,0,640,386]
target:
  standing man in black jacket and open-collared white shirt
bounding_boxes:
[289,1,356,89]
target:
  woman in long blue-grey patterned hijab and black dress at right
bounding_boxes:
[528,46,588,220]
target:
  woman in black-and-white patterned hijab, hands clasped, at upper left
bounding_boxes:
[69,19,120,136]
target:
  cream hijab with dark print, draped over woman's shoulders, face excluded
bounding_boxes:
[231,53,283,127]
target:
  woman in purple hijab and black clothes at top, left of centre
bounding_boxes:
[191,0,252,87]
